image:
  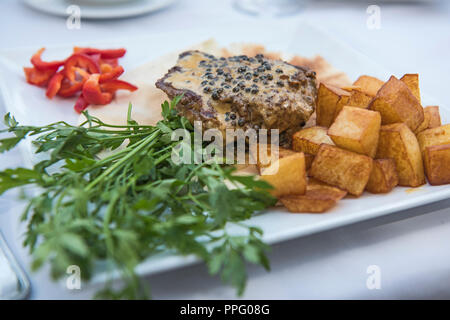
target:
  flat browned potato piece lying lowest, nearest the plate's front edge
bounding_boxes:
[280,182,347,213]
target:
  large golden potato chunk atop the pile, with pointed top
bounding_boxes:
[369,76,424,131]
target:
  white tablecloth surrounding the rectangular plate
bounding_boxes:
[0,0,450,299]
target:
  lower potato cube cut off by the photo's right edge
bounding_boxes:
[424,144,450,186]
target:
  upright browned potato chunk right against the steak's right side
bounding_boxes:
[316,83,350,127]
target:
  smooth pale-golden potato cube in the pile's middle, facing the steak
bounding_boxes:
[328,106,381,158]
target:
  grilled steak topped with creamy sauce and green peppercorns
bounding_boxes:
[156,51,317,144]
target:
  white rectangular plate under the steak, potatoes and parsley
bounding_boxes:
[0,23,450,282]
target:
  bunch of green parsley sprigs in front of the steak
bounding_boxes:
[0,97,274,298]
